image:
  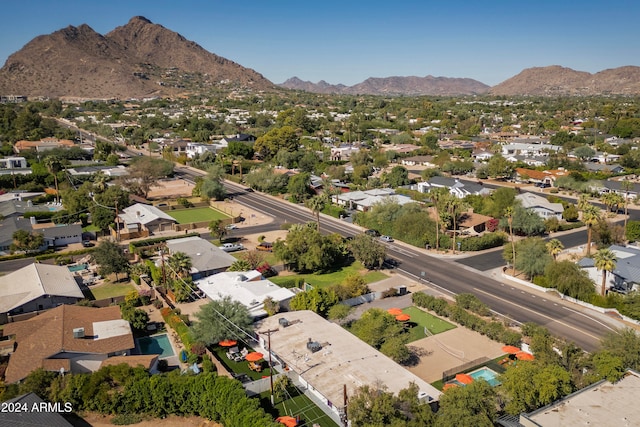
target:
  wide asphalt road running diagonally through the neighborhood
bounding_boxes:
[191,174,613,351]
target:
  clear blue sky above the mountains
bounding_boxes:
[0,0,640,86]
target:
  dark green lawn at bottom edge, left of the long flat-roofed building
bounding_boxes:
[260,387,338,427]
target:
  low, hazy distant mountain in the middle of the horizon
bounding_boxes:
[278,76,490,96]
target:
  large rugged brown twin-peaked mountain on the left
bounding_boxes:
[0,16,274,98]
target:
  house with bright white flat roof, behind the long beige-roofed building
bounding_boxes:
[195,270,295,318]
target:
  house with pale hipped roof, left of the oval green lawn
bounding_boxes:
[111,203,177,240]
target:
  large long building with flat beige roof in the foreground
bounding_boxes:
[256,310,441,425]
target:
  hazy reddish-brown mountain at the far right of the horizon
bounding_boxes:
[489,65,640,96]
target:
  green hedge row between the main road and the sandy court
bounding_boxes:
[411,292,522,345]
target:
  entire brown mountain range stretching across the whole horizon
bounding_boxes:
[0,16,640,99]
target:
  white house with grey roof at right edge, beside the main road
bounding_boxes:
[578,245,640,294]
